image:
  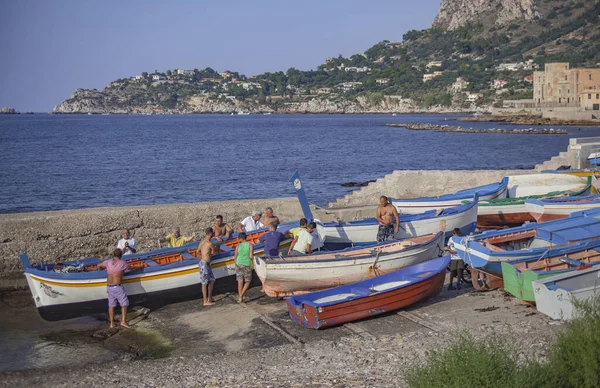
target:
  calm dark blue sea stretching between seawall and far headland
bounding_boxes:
[0,114,600,213]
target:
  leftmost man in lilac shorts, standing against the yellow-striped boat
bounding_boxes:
[98,248,131,329]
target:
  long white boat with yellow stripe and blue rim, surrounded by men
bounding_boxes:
[20,231,290,321]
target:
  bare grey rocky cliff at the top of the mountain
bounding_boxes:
[432,0,536,30]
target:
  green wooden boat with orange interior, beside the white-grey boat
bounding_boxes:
[502,241,600,303]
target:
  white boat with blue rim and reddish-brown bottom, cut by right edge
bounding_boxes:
[525,194,600,222]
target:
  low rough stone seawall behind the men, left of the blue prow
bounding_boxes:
[0,198,302,290]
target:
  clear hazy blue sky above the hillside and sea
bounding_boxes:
[0,0,441,112]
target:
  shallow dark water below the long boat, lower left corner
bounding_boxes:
[0,292,120,372]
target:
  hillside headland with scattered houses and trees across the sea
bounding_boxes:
[54,0,600,113]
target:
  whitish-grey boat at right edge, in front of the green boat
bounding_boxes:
[532,265,600,320]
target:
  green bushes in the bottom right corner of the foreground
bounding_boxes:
[406,295,600,388]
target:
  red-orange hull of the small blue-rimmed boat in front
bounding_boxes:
[286,256,449,329]
